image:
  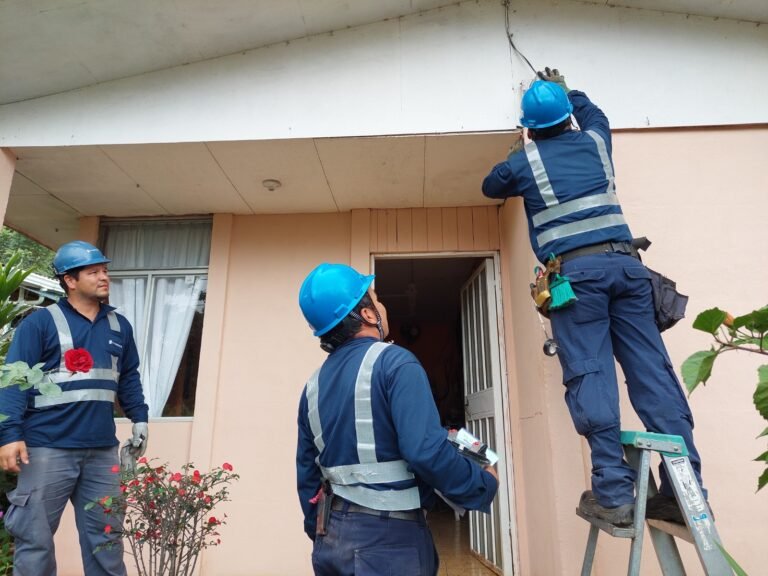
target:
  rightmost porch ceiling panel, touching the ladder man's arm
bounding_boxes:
[424,134,513,208]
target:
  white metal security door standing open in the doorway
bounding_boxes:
[461,258,513,576]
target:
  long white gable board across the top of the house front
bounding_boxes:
[0,0,768,147]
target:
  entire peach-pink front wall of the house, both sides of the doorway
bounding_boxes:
[45,128,768,576]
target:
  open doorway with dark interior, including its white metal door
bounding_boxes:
[374,255,513,576]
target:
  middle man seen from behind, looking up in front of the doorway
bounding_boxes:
[296,264,498,576]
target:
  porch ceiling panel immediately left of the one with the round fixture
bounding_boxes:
[102,142,251,214]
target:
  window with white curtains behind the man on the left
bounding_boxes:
[101,219,211,418]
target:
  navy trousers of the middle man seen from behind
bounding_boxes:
[312,510,439,576]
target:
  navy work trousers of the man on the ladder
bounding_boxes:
[551,253,706,508]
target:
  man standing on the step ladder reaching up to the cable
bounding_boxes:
[483,68,706,525]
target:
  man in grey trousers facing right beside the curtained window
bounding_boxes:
[0,241,149,576]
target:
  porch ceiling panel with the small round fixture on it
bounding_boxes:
[208,140,338,214]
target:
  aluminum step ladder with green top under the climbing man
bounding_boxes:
[576,431,733,576]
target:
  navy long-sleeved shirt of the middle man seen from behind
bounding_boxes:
[296,338,498,539]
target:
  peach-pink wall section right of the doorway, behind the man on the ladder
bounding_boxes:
[500,128,768,576]
